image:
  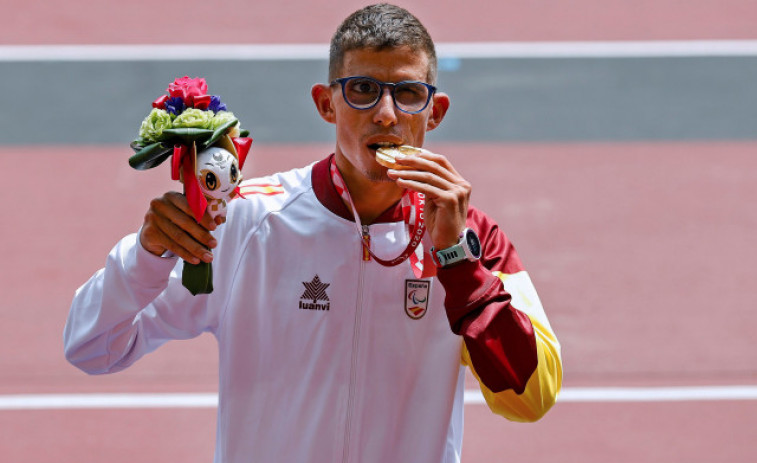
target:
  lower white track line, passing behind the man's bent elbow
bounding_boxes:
[0,386,757,411]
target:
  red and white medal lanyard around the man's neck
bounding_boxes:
[329,157,426,278]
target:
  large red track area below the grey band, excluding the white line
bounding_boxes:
[0,142,757,463]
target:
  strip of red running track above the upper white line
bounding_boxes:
[0,0,757,44]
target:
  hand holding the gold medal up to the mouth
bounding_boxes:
[387,149,472,249]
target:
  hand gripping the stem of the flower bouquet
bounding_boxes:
[139,191,224,264]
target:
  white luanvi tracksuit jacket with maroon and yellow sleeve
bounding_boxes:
[64,159,562,463]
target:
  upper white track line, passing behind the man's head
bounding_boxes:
[0,40,757,62]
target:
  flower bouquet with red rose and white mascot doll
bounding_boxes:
[129,76,252,295]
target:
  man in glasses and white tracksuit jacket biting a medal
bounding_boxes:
[65,4,562,463]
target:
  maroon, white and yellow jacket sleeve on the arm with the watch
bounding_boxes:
[437,208,562,421]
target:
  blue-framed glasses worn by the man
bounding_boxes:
[331,76,436,114]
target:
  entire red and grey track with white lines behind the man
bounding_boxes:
[0,0,757,463]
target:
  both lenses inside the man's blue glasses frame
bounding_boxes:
[344,77,429,111]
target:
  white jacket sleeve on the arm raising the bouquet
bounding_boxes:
[63,235,217,374]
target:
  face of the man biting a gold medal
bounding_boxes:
[313,47,449,187]
